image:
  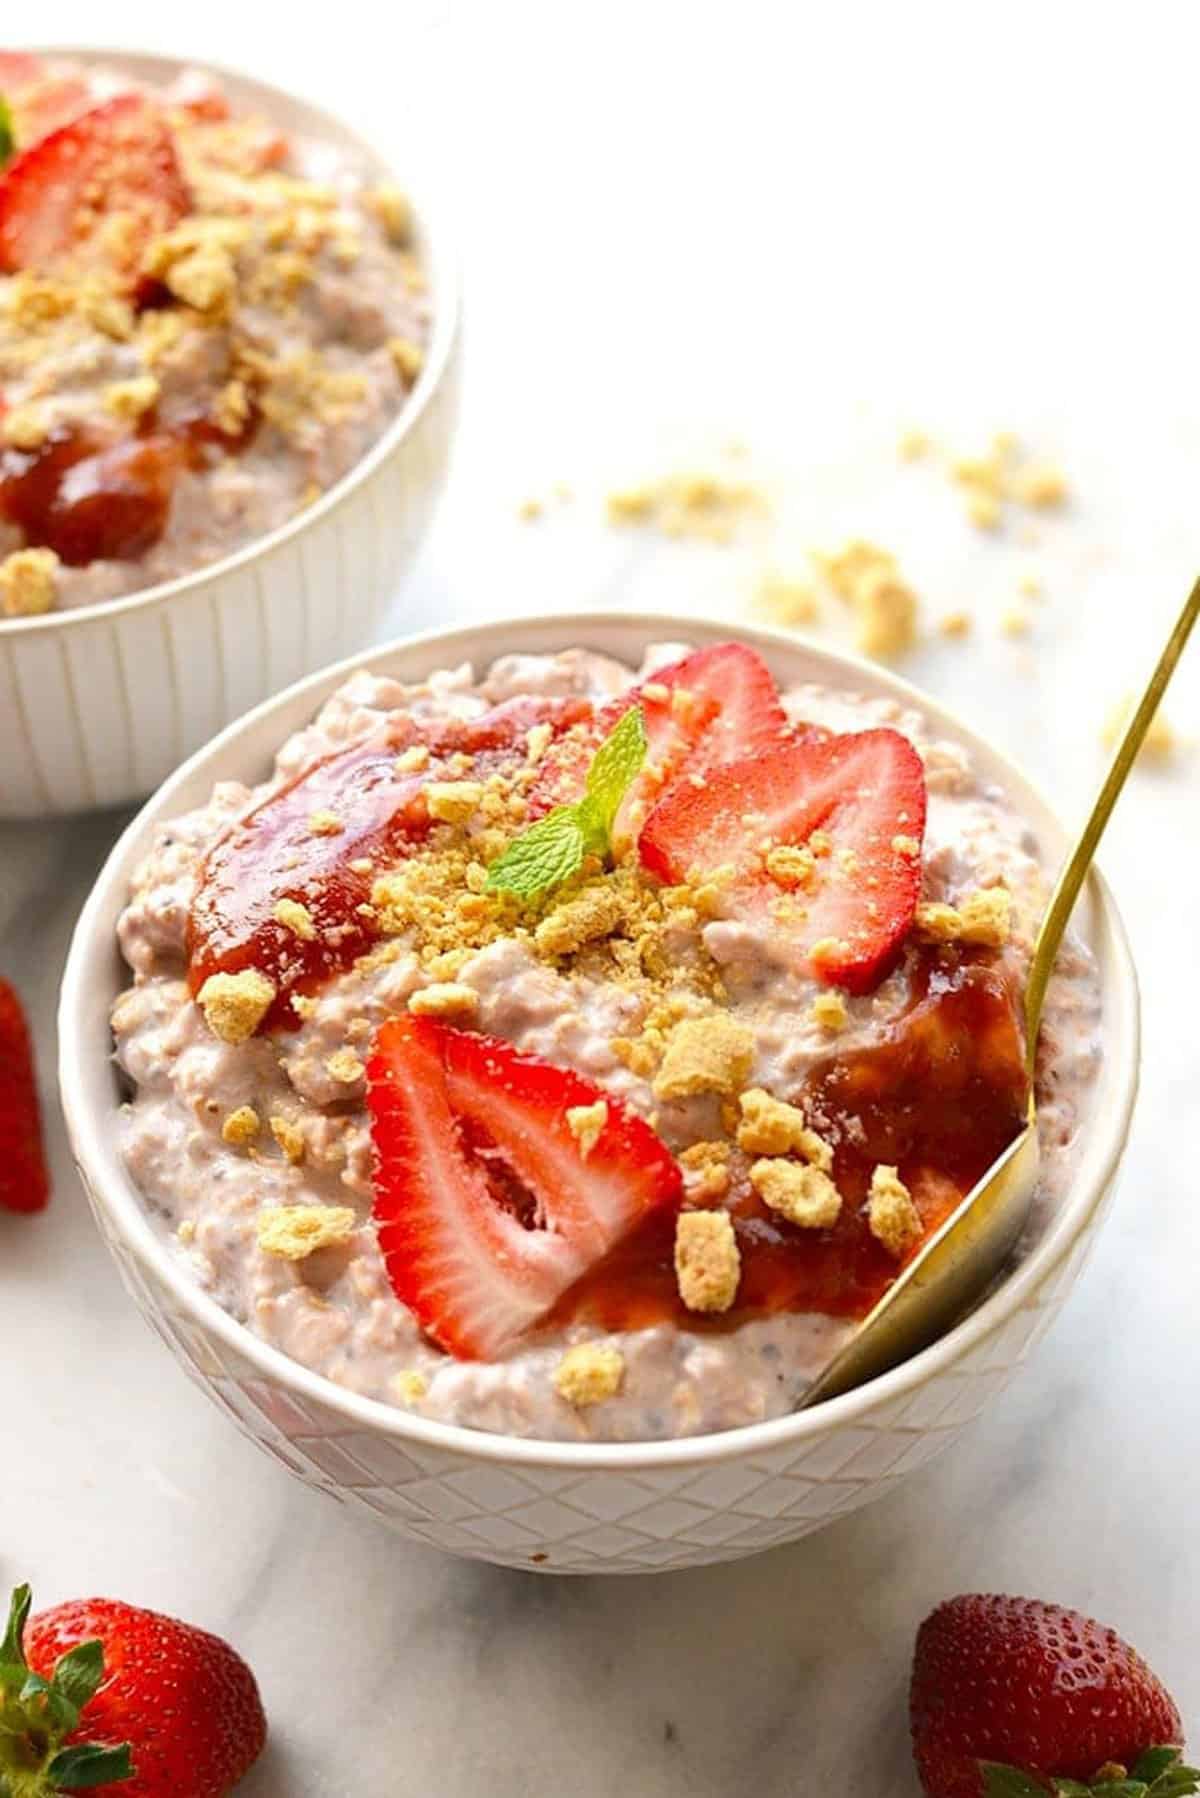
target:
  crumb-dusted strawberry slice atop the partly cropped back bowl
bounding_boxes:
[0,93,191,273]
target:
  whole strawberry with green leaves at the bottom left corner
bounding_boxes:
[0,1586,266,1798]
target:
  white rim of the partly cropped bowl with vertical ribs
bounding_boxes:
[0,43,462,642]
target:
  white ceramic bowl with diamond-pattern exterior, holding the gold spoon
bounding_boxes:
[59,615,1139,1573]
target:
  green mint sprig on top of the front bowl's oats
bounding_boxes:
[488,705,646,901]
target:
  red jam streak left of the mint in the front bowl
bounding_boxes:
[187,699,590,1028]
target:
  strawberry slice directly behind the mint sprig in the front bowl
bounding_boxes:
[529,644,788,834]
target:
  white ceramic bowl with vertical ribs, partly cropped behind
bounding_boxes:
[0,49,459,818]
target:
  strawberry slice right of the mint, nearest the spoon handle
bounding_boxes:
[640,730,925,992]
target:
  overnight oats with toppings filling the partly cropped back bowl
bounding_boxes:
[0,50,430,628]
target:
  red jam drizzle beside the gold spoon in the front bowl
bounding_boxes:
[549,955,1027,1331]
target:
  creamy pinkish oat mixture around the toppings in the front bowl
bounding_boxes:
[113,645,1101,1440]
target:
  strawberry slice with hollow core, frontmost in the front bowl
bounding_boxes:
[367,1018,682,1361]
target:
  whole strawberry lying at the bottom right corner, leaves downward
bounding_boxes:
[910,1593,1200,1798]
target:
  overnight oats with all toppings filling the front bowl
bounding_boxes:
[113,644,1101,1440]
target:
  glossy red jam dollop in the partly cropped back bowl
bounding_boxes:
[0,412,257,568]
